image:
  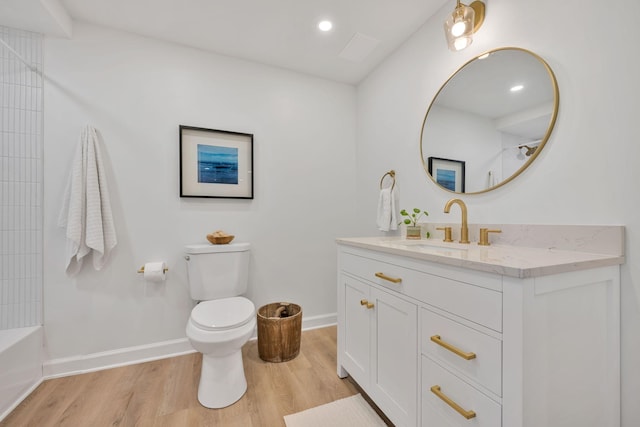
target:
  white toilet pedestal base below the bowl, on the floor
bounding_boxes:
[198,350,247,409]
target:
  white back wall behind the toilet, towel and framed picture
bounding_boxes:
[44,24,356,359]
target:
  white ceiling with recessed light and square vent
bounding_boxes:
[0,0,455,84]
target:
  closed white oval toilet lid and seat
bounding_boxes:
[191,297,255,331]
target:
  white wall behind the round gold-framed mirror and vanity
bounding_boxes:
[357,0,640,427]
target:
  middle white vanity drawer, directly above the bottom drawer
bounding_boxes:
[420,308,502,396]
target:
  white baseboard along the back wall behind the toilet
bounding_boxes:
[42,313,338,379]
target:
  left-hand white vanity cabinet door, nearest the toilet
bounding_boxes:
[342,276,372,388]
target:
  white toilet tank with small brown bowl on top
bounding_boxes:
[185,243,250,301]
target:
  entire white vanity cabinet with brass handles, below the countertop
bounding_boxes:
[338,243,620,427]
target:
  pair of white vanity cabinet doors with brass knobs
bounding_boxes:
[340,275,418,425]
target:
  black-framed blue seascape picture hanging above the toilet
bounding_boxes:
[180,125,253,199]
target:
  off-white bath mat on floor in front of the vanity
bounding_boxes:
[284,394,387,427]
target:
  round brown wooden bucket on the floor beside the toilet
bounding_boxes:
[257,302,302,362]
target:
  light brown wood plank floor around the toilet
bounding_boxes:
[0,327,388,427]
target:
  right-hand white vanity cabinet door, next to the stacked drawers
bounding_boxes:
[370,288,418,426]
